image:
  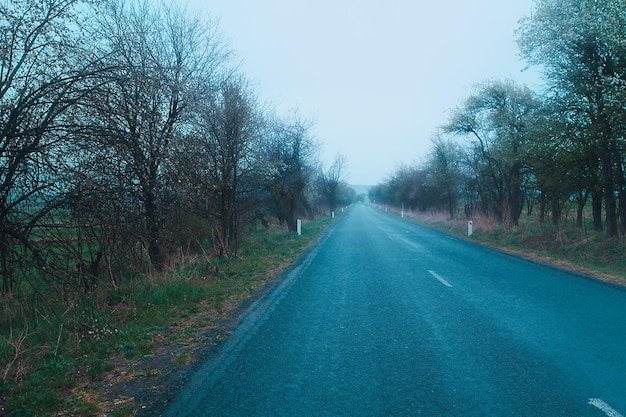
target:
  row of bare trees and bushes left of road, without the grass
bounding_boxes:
[0,0,354,297]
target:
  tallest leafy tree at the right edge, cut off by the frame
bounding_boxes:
[518,0,626,236]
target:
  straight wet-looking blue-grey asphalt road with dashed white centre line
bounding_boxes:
[166,205,626,417]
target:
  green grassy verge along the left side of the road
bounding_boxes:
[0,214,333,416]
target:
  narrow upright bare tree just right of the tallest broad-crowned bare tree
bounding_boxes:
[181,76,261,257]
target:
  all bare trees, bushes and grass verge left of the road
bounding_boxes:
[0,0,354,416]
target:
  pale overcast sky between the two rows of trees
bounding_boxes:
[181,0,538,185]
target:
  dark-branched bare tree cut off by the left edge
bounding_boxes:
[0,0,103,293]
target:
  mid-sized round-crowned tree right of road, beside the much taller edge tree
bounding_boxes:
[444,81,540,225]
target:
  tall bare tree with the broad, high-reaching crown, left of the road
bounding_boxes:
[85,0,227,268]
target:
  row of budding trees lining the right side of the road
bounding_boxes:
[370,0,626,237]
